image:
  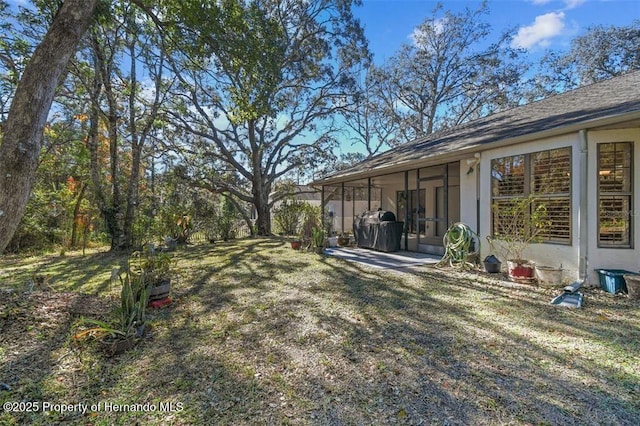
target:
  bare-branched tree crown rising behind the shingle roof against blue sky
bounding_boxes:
[356,3,527,145]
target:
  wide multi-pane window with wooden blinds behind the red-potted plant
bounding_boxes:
[491,148,571,244]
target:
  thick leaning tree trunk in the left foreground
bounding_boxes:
[0,0,98,253]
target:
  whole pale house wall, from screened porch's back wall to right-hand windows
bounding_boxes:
[318,121,640,286]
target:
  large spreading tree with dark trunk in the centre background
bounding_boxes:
[161,0,368,234]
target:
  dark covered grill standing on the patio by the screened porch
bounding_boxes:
[353,210,404,252]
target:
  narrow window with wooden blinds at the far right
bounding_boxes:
[598,142,633,248]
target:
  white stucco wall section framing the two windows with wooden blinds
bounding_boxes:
[480,128,640,286]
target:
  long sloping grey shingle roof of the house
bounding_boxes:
[317,71,640,183]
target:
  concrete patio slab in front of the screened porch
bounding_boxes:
[324,247,441,270]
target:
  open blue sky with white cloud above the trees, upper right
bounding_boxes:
[355,0,640,64]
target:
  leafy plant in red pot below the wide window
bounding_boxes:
[490,195,550,283]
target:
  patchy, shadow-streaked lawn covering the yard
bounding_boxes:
[0,239,640,425]
